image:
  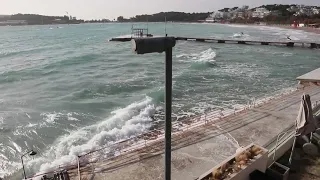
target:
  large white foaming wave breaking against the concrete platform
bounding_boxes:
[28,97,156,176]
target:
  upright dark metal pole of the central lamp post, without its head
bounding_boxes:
[165,48,172,180]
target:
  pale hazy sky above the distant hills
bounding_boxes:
[0,0,320,19]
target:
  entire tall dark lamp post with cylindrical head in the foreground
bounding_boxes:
[132,37,176,180]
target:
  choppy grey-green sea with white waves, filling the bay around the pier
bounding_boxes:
[0,23,320,177]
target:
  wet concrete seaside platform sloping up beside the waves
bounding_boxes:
[74,86,320,180]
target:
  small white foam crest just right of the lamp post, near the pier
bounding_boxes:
[176,48,217,62]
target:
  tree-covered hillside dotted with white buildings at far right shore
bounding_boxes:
[208,4,320,24]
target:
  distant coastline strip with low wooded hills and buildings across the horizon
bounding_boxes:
[0,4,320,28]
